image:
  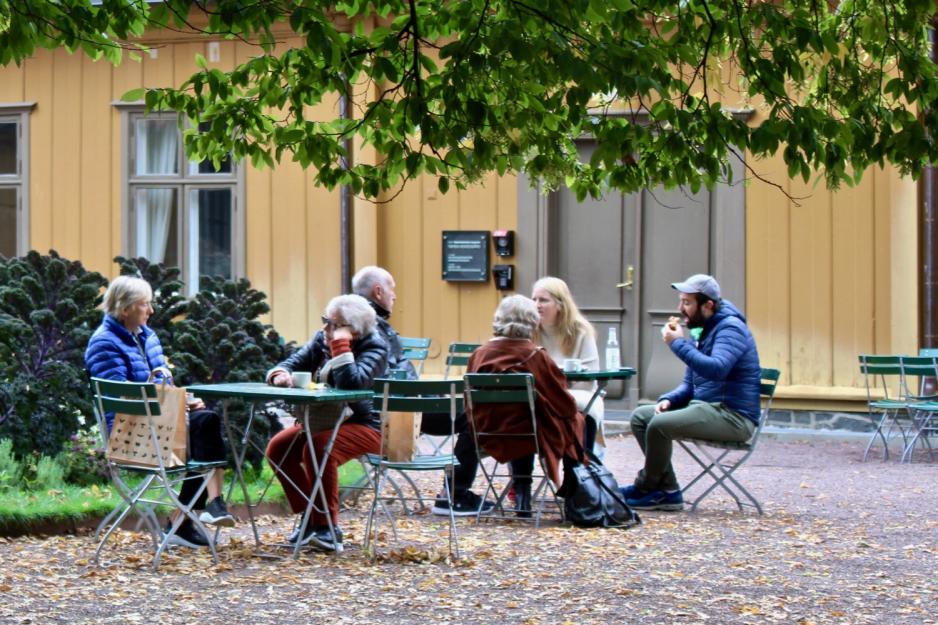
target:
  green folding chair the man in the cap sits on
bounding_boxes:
[675,369,781,514]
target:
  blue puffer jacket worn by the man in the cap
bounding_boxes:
[659,300,761,423]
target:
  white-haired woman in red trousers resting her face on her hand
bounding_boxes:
[267,295,388,551]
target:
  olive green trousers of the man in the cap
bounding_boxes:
[631,400,756,491]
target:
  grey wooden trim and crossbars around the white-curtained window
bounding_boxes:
[112,101,247,293]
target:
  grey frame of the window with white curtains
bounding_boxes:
[114,102,247,296]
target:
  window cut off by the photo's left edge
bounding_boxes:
[0,104,32,258]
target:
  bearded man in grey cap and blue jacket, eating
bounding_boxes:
[622,274,760,510]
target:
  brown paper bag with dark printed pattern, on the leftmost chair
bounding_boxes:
[108,384,187,468]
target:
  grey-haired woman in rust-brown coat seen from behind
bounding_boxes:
[457,295,583,516]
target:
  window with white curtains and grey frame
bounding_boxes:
[125,112,244,295]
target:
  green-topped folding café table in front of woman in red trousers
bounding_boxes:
[186,382,373,558]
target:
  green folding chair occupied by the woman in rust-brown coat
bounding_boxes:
[463,373,564,527]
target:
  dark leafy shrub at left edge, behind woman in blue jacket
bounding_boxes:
[0,250,107,457]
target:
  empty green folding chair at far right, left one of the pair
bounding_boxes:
[859,354,911,462]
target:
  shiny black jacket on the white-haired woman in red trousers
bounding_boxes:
[275,328,388,430]
